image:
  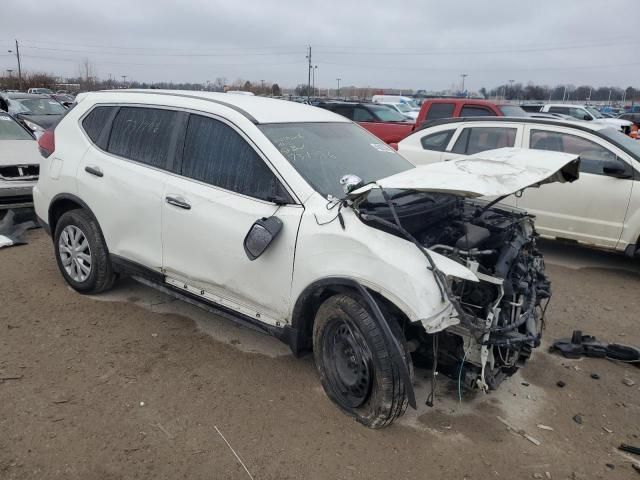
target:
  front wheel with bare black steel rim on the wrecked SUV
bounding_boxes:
[313,294,412,428]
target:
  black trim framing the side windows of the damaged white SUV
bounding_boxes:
[78,102,302,206]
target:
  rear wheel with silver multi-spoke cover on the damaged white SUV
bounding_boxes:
[53,209,117,293]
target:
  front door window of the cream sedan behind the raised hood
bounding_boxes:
[529,130,617,175]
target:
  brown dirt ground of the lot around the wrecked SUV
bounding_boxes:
[0,231,640,480]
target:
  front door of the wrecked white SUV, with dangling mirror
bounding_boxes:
[162,114,304,325]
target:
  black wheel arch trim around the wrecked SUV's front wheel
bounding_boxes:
[289,277,417,409]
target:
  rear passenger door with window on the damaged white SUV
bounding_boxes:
[77,106,180,271]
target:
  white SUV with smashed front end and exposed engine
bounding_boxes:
[34,90,579,427]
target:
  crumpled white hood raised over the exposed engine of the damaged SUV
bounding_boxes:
[350,148,580,198]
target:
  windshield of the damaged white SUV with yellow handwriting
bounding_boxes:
[259,124,414,198]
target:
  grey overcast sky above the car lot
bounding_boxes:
[0,0,640,90]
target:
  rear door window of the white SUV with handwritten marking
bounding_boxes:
[107,107,178,169]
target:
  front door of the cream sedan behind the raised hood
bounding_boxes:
[517,125,633,248]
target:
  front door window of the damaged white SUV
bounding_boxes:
[182,115,291,203]
